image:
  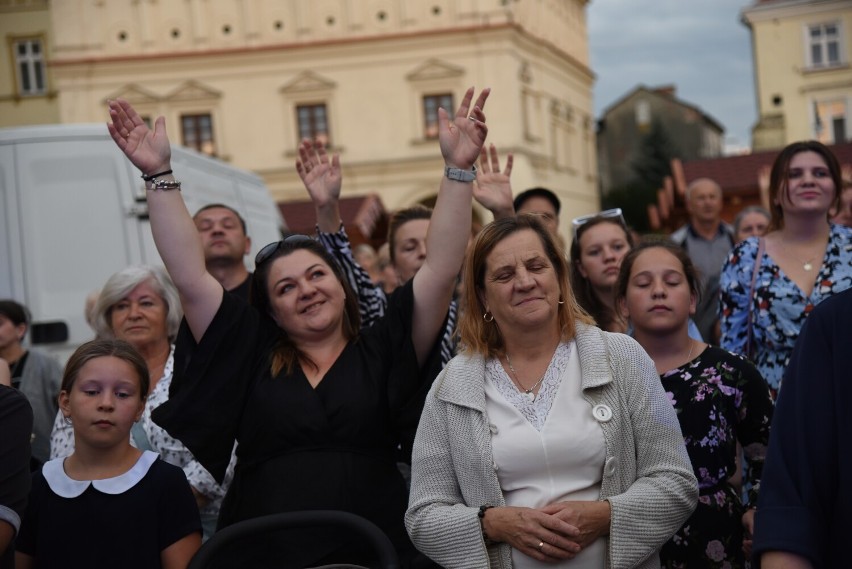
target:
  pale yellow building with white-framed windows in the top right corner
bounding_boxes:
[742,0,852,151]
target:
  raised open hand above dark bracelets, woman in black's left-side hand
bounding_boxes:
[107,99,172,174]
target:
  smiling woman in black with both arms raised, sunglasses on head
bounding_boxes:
[108,88,489,567]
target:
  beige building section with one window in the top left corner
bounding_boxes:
[0,0,59,127]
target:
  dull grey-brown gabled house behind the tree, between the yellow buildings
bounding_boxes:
[597,85,725,194]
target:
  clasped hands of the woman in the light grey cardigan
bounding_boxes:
[483,507,580,562]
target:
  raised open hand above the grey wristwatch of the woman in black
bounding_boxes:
[438,87,491,170]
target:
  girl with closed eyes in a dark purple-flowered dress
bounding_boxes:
[616,241,772,568]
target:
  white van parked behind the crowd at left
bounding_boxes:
[0,124,285,361]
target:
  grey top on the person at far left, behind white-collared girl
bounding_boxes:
[19,348,62,463]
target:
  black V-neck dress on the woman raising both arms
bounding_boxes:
[154,283,440,567]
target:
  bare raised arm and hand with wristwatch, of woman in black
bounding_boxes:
[411,87,491,363]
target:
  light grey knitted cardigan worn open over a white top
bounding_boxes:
[405,324,698,569]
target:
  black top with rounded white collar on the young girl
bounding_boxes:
[15,453,201,569]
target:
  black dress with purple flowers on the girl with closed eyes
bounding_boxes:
[660,346,773,569]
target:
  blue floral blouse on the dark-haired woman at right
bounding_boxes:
[720,225,852,397]
